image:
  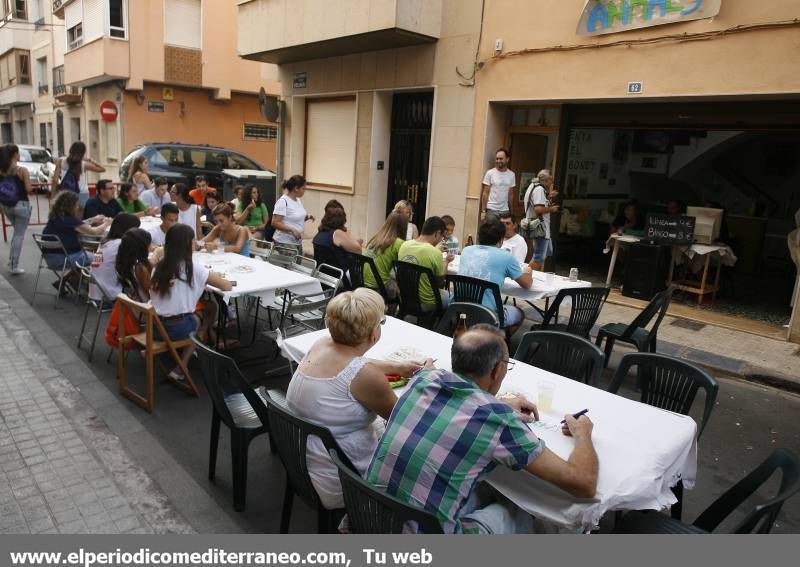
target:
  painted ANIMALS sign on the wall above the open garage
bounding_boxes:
[576,0,722,36]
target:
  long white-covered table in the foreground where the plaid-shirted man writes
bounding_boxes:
[282,317,697,530]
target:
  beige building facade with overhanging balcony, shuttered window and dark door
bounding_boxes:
[238,0,482,239]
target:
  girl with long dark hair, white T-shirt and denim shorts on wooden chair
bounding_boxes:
[150,223,231,381]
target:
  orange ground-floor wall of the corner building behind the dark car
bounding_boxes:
[123,85,275,170]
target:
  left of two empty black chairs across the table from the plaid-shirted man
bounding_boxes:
[514,331,604,386]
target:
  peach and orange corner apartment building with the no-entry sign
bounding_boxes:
[43,0,278,176]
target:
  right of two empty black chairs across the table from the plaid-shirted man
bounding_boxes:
[608,353,719,519]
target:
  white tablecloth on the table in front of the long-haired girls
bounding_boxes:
[194,252,322,305]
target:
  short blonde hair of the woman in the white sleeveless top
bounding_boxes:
[325,287,386,346]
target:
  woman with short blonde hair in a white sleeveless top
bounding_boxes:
[286,288,431,510]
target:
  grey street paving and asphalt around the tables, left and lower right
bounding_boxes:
[0,237,800,533]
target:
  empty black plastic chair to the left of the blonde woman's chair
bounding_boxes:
[191,333,283,512]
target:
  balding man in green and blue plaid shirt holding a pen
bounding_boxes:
[366,325,597,533]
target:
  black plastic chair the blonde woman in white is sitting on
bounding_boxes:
[267,399,356,534]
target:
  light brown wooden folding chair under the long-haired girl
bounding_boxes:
[117,293,200,413]
